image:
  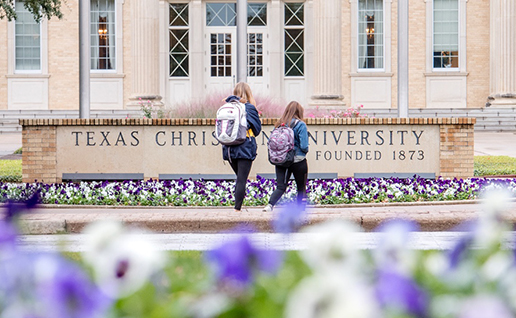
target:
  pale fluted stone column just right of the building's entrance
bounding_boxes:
[310,0,344,107]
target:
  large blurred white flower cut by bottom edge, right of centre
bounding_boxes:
[285,272,381,318]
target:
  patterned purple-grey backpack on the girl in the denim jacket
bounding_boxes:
[267,120,298,168]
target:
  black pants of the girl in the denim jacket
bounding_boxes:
[269,159,308,205]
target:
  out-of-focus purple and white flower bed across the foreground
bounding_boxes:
[0,191,516,318]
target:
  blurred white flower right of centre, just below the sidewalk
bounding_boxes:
[302,220,366,271]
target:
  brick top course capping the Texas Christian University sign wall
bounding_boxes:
[19,117,476,126]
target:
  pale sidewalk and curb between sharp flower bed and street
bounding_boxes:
[16,201,516,234]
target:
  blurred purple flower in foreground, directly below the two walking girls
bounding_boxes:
[206,235,281,289]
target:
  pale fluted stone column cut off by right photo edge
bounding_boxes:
[487,0,516,107]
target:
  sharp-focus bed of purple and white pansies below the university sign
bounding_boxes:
[0,178,516,206]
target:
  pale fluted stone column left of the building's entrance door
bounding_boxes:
[128,0,163,107]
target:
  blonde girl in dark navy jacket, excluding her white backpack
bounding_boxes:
[222,82,262,212]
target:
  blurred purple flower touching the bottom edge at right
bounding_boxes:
[376,270,428,317]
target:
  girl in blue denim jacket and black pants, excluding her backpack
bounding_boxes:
[263,101,308,212]
